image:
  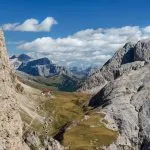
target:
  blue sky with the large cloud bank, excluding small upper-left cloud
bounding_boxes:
[0,0,150,66]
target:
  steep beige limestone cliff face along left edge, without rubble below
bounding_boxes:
[0,31,22,150]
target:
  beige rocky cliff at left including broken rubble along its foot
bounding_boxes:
[0,30,64,150]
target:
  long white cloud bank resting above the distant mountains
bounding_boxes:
[18,26,150,66]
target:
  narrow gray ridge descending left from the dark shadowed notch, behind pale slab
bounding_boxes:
[80,43,134,93]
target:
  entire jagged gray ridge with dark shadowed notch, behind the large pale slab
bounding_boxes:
[80,40,150,93]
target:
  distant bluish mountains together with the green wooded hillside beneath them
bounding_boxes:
[10,54,90,92]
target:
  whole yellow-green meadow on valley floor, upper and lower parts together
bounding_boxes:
[21,88,118,150]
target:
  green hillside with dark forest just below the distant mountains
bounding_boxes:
[15,71,84,92]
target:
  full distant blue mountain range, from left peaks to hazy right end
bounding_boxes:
[10,54,96,78]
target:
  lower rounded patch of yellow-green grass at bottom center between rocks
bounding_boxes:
[63,114,118,150]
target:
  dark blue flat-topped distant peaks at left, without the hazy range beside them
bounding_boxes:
[10,54,68,77]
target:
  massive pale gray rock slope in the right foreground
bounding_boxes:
[89,65,150,150]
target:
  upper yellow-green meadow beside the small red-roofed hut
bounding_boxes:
[20,91,89,136]
